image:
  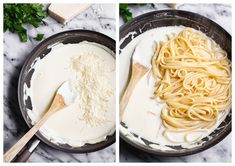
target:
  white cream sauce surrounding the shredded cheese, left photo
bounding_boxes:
[24,41,115,147]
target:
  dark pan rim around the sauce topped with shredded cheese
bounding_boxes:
[18,30,115,153]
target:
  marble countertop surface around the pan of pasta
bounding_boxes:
[119,4,232,162]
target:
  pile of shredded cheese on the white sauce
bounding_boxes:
[71,52,114,126]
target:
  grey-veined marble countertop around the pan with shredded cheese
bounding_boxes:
[3,4,116,162]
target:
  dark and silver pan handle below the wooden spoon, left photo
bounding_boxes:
[14,139,40,163]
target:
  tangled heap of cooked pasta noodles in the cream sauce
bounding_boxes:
[152,28,231,132]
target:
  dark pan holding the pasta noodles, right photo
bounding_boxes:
[120,10,232,157]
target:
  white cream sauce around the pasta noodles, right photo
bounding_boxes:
[119,26,228,150]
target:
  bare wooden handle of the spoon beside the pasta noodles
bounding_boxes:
[119,63,148,121]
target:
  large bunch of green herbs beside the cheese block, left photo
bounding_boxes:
[4,4,47,42]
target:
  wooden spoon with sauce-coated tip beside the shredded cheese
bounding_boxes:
[4,82,75,162]
